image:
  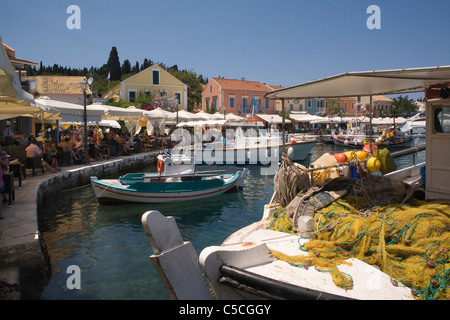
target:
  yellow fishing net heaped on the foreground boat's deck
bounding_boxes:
[269,196,450,300]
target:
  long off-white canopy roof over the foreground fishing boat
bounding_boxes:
[264,66,450,100]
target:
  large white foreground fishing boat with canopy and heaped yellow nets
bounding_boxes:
[142,66,450,300]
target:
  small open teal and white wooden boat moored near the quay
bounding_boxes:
[91,169,247,205]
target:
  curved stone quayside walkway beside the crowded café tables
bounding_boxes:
[0,150,161,298]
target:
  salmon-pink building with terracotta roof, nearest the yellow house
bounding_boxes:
[202,78,279,114]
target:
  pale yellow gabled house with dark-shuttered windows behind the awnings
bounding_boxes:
[120,64,188,110]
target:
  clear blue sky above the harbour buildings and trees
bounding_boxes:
[0,0,450,94]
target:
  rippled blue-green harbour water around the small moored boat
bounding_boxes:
[33,141,425,300]
